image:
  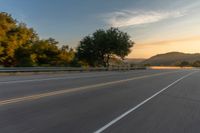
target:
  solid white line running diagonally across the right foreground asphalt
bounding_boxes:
[94,71,197,133]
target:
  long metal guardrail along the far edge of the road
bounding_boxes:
[0,66,146,73]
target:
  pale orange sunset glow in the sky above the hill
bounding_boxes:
[128,36,200,58]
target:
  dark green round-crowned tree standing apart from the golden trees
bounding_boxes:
[77,28,134,67]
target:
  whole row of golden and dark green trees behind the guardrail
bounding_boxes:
[0,12,134,67]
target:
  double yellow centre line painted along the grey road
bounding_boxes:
[0,71,178,106]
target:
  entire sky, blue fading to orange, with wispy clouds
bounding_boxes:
[0,0,200,58]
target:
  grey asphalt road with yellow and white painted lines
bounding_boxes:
[0,69,200,133]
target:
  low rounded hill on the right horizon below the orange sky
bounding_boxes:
[142,52,200,66]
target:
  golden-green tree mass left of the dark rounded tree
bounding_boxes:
[0,12,75,66]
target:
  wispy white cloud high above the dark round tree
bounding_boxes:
[104,10,186,27]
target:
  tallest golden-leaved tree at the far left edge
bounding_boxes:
[0,13,38,66]
